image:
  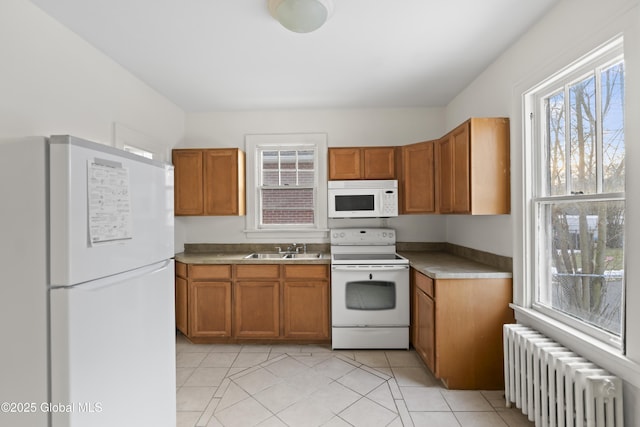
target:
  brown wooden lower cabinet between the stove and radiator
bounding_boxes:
[411,269,514,390]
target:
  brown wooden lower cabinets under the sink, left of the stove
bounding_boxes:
[176,262,331,342]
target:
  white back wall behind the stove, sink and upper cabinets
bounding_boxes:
[176,108,446,250]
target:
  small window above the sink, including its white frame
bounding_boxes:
[246,134,327,237]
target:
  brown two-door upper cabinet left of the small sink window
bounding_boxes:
[172,148,245,215]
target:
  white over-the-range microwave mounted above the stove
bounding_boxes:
[328,179,398,218]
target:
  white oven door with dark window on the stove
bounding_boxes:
[331,265,409,327]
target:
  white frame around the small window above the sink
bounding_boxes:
[245,133,328,238]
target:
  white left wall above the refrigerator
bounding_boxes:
[0,0,184,151]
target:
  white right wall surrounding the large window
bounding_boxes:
[446,0,640,426]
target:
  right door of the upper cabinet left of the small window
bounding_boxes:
[204,149,244,215]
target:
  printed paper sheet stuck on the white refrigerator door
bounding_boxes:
[87,159,132,245]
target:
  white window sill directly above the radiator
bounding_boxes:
[510,304,640,388]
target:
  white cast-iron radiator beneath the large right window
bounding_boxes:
[503,324,624,427]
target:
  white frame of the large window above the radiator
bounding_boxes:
[523,37,627,354]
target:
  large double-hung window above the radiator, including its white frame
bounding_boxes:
[525,39,625,350]
